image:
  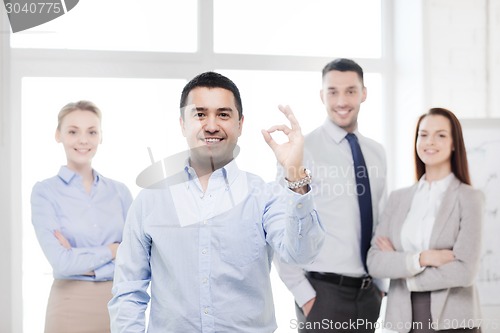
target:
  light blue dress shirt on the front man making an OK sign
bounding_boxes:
[109,161,324,333]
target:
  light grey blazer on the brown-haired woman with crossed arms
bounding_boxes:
[367,178,484,332]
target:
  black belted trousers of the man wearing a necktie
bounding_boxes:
[295,277,382,333]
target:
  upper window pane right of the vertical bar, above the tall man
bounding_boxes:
[214,0,382,58]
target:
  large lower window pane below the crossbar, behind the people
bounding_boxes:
[22,69,383,333]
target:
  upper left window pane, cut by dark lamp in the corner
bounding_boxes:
[11,0,198,52]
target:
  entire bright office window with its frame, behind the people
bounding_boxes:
[11,0,388,333]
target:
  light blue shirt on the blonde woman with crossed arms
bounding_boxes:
[31,166,132,281]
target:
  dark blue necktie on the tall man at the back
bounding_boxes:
[346,133,373,272]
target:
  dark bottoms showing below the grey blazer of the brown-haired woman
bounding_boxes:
[410,292,481,333]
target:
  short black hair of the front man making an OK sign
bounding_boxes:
[180,72,243,119]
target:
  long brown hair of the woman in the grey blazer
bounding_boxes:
[414,108,471,185]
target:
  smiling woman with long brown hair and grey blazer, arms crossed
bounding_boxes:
[368,108,484,333]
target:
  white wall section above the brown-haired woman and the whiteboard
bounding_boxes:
[424,0,494,118]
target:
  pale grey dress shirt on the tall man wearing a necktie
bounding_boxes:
[275,119,387,306]
